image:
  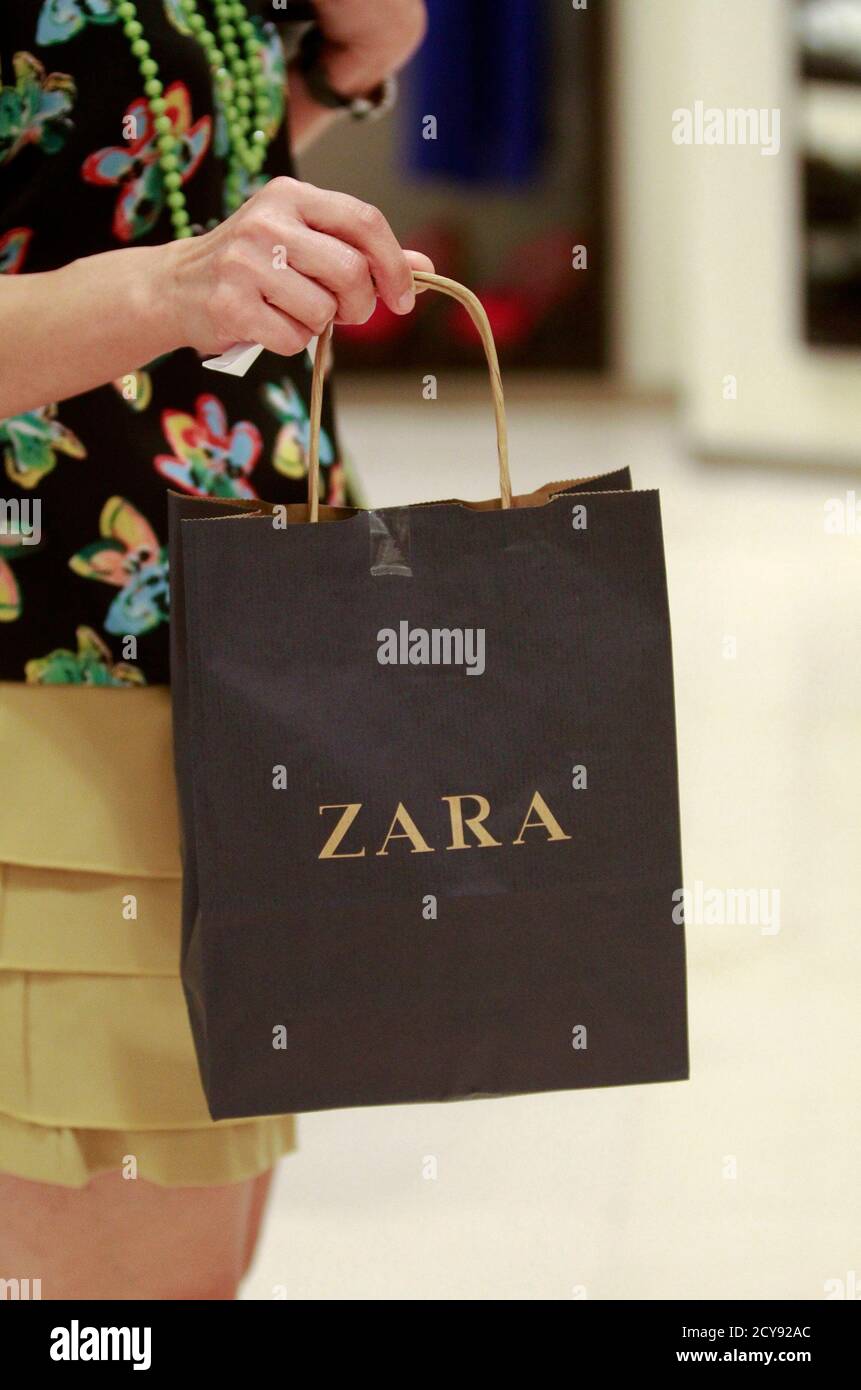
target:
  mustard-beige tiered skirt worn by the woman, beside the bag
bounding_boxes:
[0,682,293,1187]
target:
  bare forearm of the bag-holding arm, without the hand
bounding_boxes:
[0,243,181,420]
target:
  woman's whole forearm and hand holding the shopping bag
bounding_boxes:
[0,178,433,420]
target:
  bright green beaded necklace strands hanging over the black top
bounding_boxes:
[117,0,271,238]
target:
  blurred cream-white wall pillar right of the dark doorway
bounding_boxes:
[613,0,861,466]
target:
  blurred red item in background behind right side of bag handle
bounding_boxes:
[448,229,584,352]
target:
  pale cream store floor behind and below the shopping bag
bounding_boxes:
[239,381,861,1300]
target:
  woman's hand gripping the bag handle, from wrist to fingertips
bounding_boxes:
[164,176,434,356]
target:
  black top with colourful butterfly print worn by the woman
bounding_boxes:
[0,0,349,689]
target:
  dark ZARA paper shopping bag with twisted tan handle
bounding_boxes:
[171,275,687,1119]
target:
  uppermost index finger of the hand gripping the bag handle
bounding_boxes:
[282,179,415,314]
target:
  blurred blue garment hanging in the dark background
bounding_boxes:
[408,0,549,183]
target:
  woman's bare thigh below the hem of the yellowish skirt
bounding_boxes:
[0,1172,271,1300]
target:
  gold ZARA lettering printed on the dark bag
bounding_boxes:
[317,791,572,859]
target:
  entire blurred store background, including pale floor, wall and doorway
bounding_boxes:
[248,0,861,1298]
